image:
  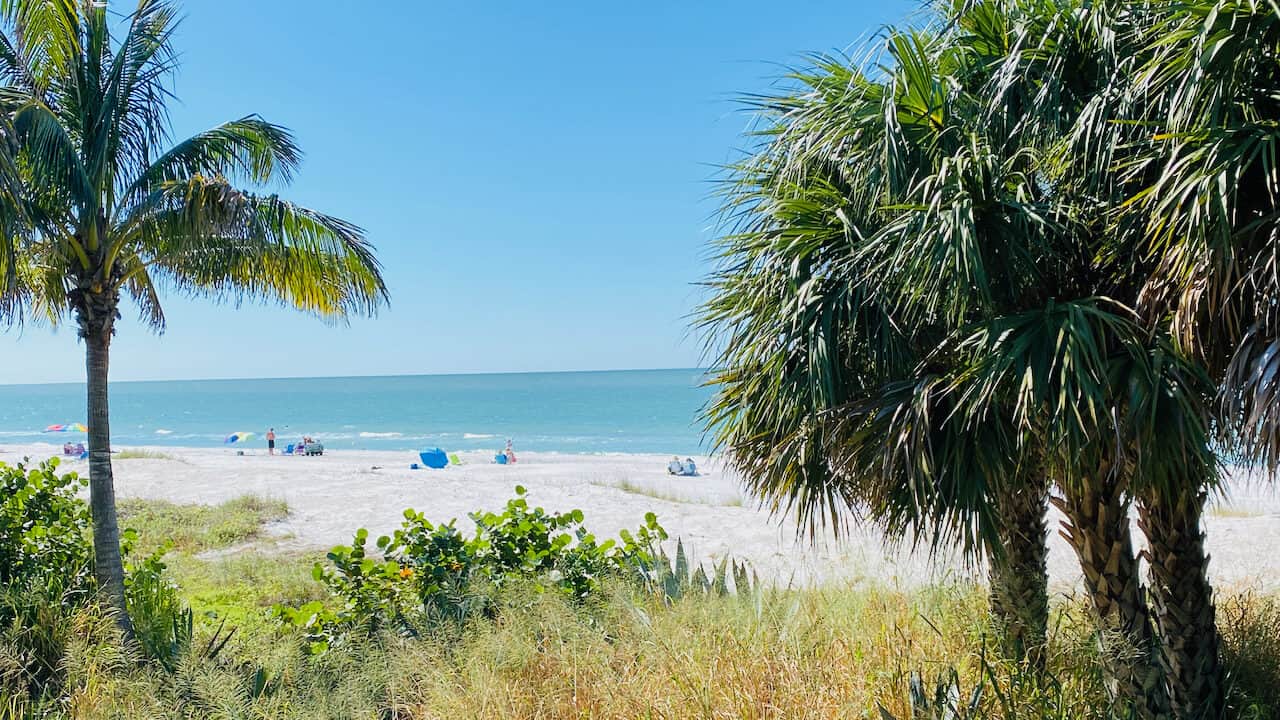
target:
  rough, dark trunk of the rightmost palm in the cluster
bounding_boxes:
[1138,491,1225,720]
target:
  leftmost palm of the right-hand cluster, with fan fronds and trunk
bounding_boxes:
[700,20,1048,662]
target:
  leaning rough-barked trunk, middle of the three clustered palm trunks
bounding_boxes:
[1053,469,1169,720]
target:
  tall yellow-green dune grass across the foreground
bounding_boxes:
[10,497,1280,720]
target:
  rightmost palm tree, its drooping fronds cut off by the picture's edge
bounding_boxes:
[1112,0,1280,717]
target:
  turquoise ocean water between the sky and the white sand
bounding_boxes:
[0,369,710,455]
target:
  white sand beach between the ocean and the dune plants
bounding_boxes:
[0,445,1280,592]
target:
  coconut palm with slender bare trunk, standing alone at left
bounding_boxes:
[0,0,387,634]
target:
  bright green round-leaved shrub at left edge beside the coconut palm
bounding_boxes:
[0,459,93,599]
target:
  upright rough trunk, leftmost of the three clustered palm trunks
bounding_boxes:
[988,474,1048,670]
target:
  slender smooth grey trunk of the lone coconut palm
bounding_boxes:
[81,301,133,639]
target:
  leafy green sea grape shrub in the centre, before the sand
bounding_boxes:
[275,486,667,653]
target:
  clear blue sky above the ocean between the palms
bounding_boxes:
[0,0,915,383]
